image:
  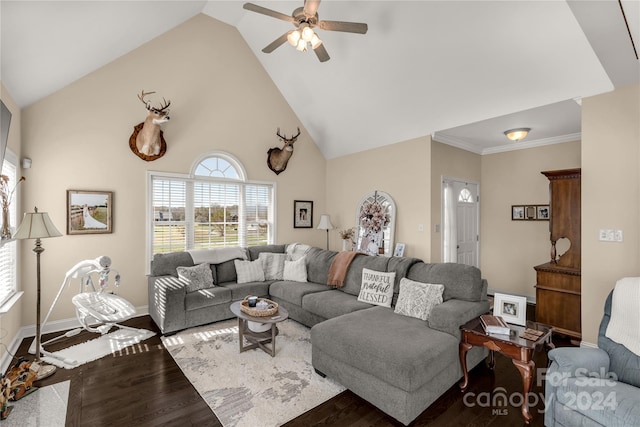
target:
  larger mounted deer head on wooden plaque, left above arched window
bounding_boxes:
[129,90,171,161]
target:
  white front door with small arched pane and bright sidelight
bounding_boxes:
[442,179,480,267]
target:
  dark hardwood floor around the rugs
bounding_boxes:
[8,310,566,427]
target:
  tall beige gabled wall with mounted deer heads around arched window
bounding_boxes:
[21,15,326,325]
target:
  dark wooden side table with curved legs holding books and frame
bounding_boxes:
[460,317,554,424]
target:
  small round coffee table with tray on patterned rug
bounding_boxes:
[230,301,289,357]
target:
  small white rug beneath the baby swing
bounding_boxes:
[42,329,155,369]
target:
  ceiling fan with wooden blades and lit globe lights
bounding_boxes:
[243,0,368,62]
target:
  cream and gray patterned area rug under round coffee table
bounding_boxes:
[162,320,344,427]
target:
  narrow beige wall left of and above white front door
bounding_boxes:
[431,141,482,262]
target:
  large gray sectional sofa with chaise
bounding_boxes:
[148,245,489,424]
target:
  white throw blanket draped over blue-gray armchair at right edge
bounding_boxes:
[604,277,640,356]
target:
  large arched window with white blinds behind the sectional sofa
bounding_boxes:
[149,151,276,257]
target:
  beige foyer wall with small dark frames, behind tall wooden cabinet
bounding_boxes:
[480,142,580,299]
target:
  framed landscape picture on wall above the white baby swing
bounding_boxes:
[67,190,113,234]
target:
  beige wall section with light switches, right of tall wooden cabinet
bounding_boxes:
[582,85,640,343]
